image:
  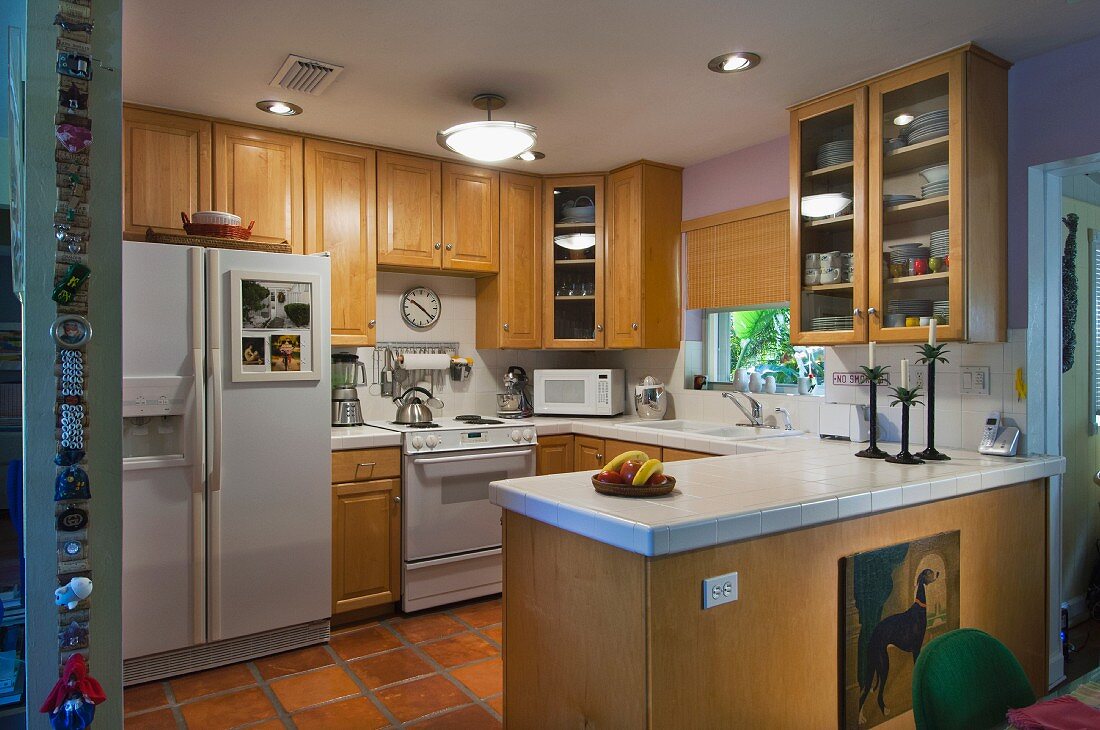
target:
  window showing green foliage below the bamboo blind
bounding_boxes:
[705,307,825,392]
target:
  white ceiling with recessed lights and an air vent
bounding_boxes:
[123,0,1100,173]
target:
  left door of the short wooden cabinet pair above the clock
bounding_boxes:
[378,152,443,268]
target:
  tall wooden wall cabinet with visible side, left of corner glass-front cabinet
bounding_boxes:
[477,173,542,350]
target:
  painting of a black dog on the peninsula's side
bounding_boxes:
[842,530,959,729]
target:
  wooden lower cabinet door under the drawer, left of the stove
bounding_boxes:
[332,479,402,613]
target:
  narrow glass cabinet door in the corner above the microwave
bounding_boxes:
[543,176,605,350]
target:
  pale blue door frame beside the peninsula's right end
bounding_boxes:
[1026,153,1100,687]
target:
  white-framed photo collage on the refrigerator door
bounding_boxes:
[230,272,321,383]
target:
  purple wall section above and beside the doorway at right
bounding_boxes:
[1009,36,1100,328]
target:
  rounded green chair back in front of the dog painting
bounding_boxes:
[913,629,1035,730]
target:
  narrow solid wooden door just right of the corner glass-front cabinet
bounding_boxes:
[604,165,645,347]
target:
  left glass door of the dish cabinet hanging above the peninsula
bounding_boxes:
[791,88,867,344]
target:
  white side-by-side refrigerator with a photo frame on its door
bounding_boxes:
[122,242,331,683]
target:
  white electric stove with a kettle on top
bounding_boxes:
[369,416,538,611]
